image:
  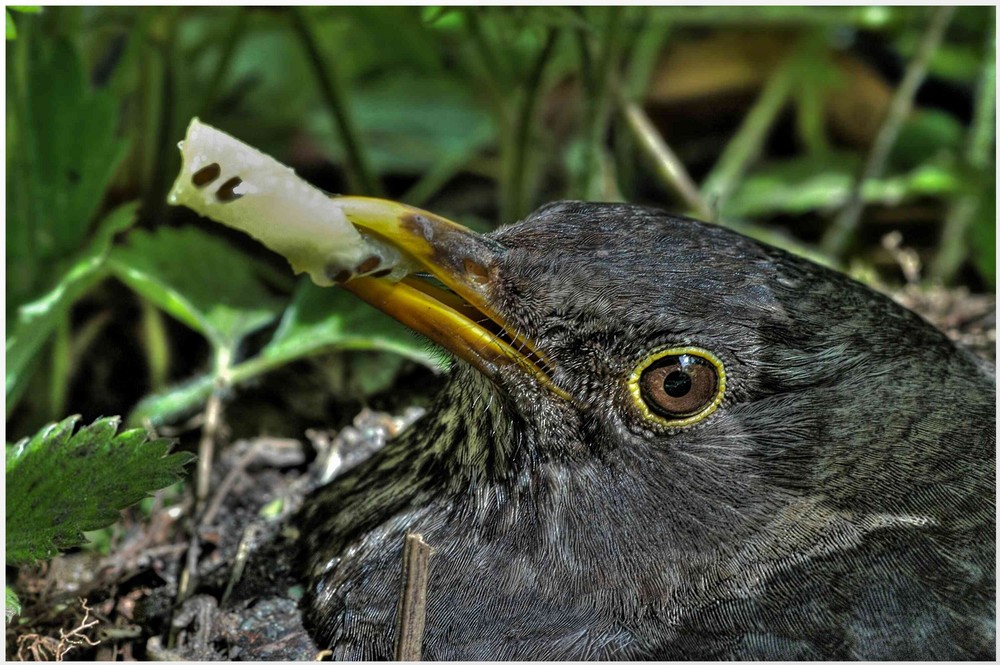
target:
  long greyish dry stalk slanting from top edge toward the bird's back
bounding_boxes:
[821,7,955,258]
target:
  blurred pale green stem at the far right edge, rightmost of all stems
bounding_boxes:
[930,9,997,283]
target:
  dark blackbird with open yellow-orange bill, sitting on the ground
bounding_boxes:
[299,199,996,660]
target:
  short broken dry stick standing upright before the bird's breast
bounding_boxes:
[395,533,432,661]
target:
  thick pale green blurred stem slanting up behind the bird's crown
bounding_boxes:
[701,52,797,218]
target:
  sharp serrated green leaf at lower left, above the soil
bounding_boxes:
[6,416,193,565]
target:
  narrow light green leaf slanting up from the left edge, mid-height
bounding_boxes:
[6,203,137,415]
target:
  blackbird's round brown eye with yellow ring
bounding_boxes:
[629,346,726,427]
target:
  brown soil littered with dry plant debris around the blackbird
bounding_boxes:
[6,286,996,660]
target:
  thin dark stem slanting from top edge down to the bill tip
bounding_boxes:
[289,7,385,196]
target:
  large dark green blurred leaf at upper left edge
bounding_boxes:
[6,37,128,312]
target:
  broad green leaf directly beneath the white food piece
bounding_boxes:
[109,226,280,349]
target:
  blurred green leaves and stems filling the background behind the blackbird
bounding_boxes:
[6,7,996,440]
